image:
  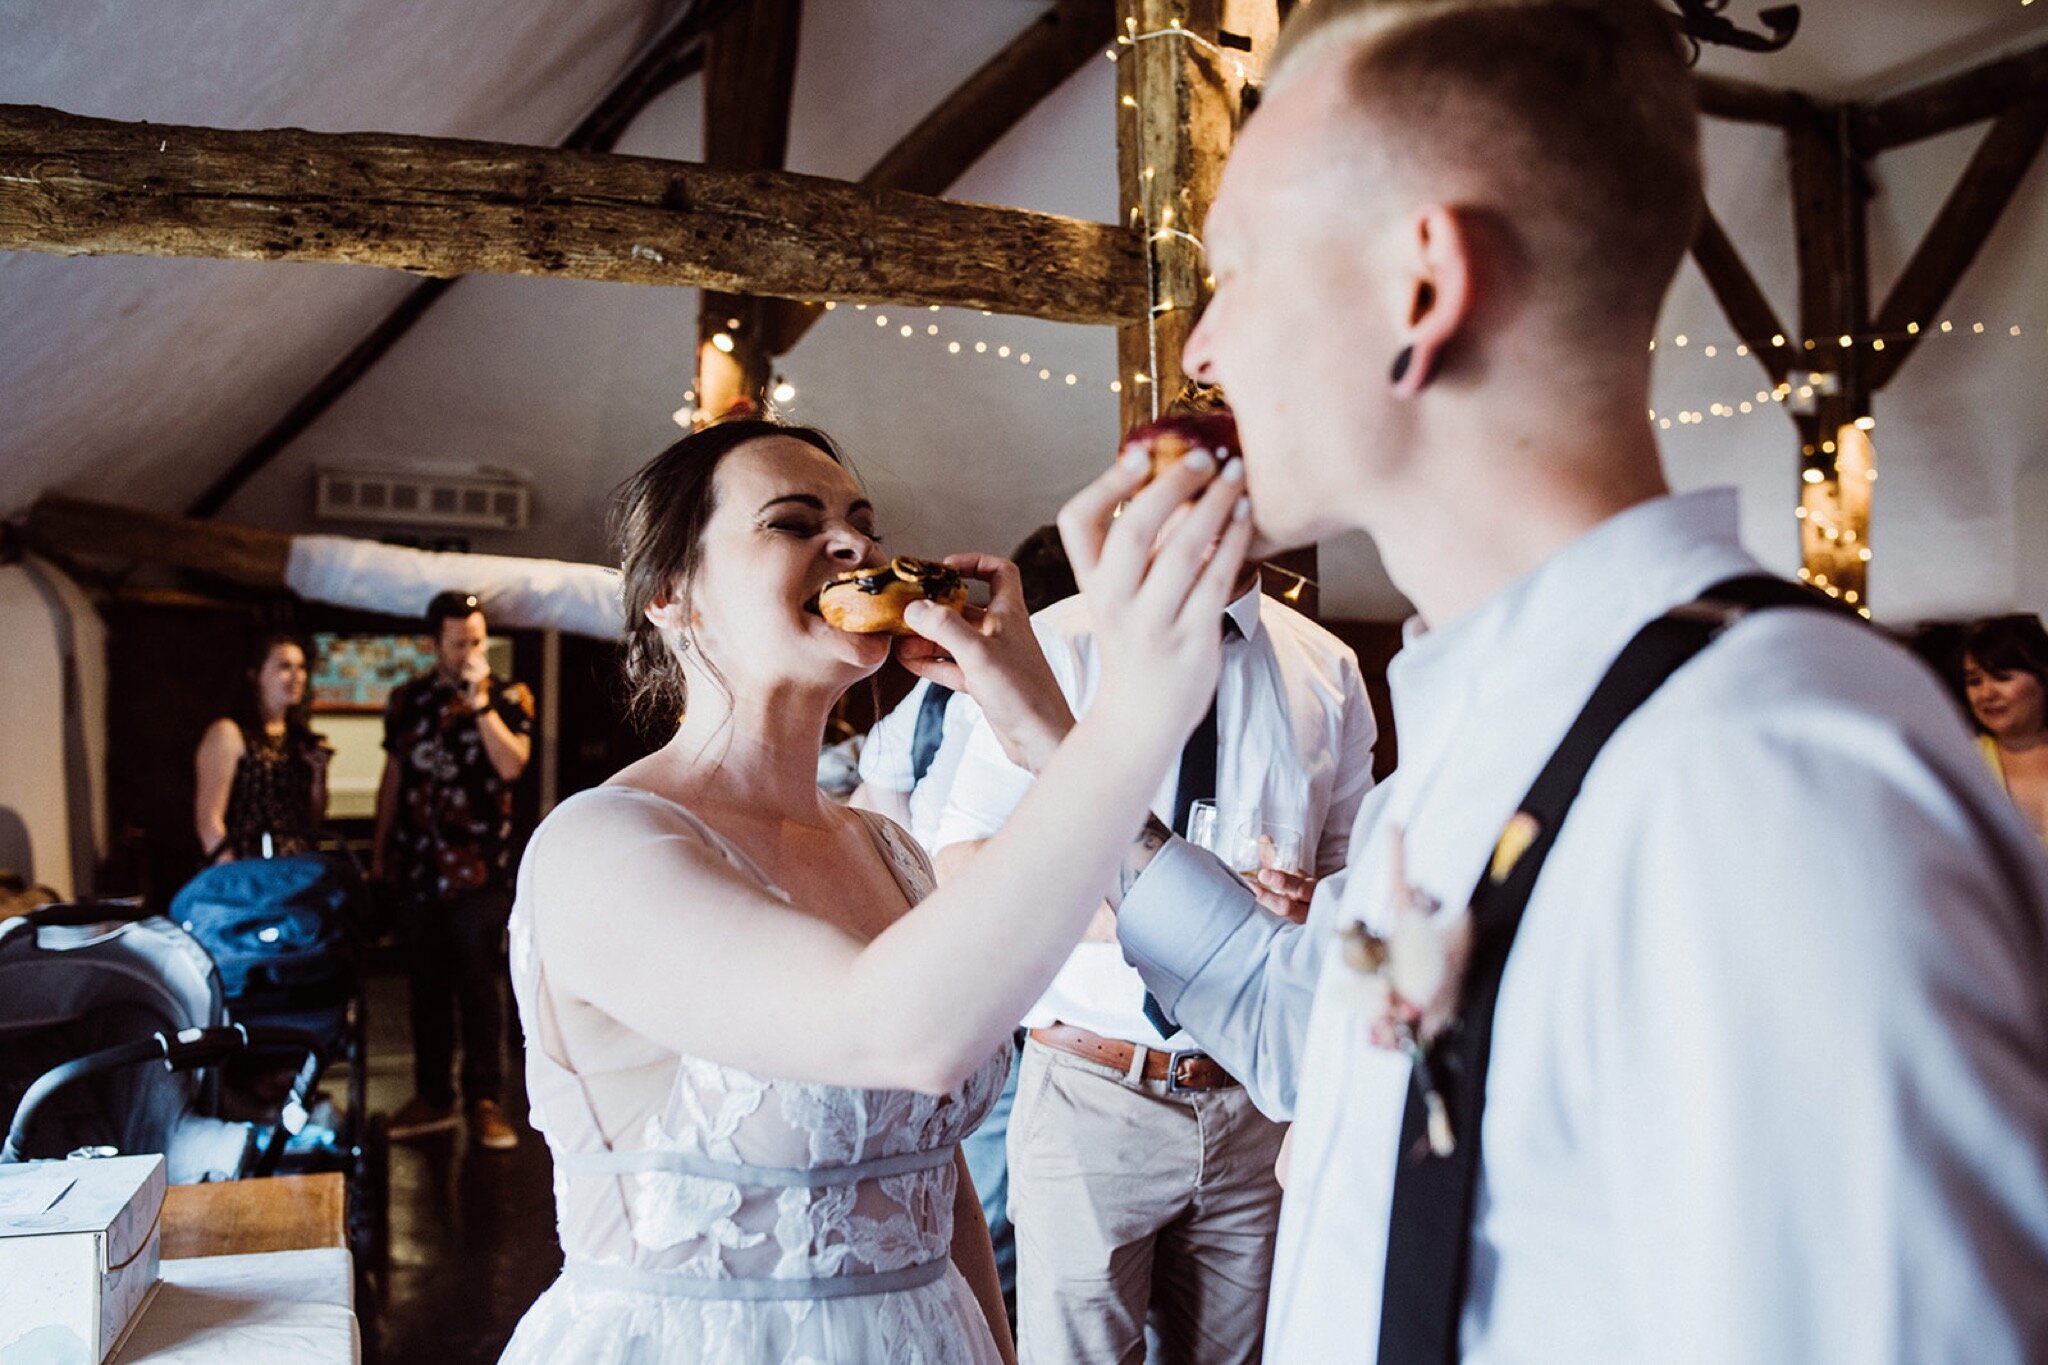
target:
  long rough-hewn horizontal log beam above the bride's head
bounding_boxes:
[0,104,1145,323]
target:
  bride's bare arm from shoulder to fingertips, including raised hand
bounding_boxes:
[528,454,1249,1093]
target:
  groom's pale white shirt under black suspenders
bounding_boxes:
[1120,491,2048,1365]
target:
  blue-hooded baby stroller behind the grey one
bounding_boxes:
[170,843,389,1285]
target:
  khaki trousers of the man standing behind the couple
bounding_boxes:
[1010,1040,1284,1365]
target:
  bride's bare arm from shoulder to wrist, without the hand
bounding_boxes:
[524,699,1171,1095]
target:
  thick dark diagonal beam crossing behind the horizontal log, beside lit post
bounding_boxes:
[764,0,1116,356]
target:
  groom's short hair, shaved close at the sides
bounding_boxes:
[1268,0,1702,327]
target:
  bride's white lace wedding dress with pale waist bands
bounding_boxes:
[502,788,1010,1365]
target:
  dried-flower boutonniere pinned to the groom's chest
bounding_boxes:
[1337,829,1473,1156]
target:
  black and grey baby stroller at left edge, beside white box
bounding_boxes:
[0,900,324,1185]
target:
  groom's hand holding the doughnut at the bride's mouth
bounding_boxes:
[897,555,1073,772]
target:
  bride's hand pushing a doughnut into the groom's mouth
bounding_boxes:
[1059,450,1251,743]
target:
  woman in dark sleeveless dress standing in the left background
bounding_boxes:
[193,634,334,866]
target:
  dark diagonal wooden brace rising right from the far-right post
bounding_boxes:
[1870,94,2048,391]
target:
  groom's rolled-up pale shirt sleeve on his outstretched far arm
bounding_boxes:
[1116,839,1346,1121]
